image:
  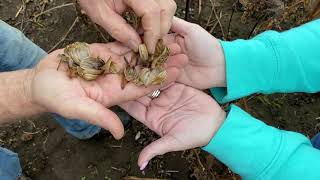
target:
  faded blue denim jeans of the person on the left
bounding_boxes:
[0,20,101,180]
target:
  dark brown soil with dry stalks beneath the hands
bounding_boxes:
[0,0,320,180]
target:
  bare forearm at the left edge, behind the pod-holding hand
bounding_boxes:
[0,69,43,124]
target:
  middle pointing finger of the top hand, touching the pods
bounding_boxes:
[124,0,161,54]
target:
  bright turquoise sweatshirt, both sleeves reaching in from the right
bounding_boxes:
[204,20,320,180]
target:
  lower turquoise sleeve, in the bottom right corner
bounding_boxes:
[204,105,320,180]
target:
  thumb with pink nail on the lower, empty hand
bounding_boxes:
[138,136,179,170]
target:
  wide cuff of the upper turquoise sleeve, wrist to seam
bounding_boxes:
[211,31,278,103]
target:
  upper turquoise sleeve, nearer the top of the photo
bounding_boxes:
[211,20,320,103]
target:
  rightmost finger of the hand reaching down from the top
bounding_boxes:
[156,0,177,37]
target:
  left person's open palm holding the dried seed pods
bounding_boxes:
[27,43,187,139]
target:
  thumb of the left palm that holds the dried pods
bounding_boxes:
[62,98,124,139]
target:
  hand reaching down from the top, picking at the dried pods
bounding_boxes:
[80,0,177,54]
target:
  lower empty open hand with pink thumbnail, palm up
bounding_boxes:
[121,84,226,170]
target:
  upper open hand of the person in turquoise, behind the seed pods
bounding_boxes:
[165,17,226,89]
